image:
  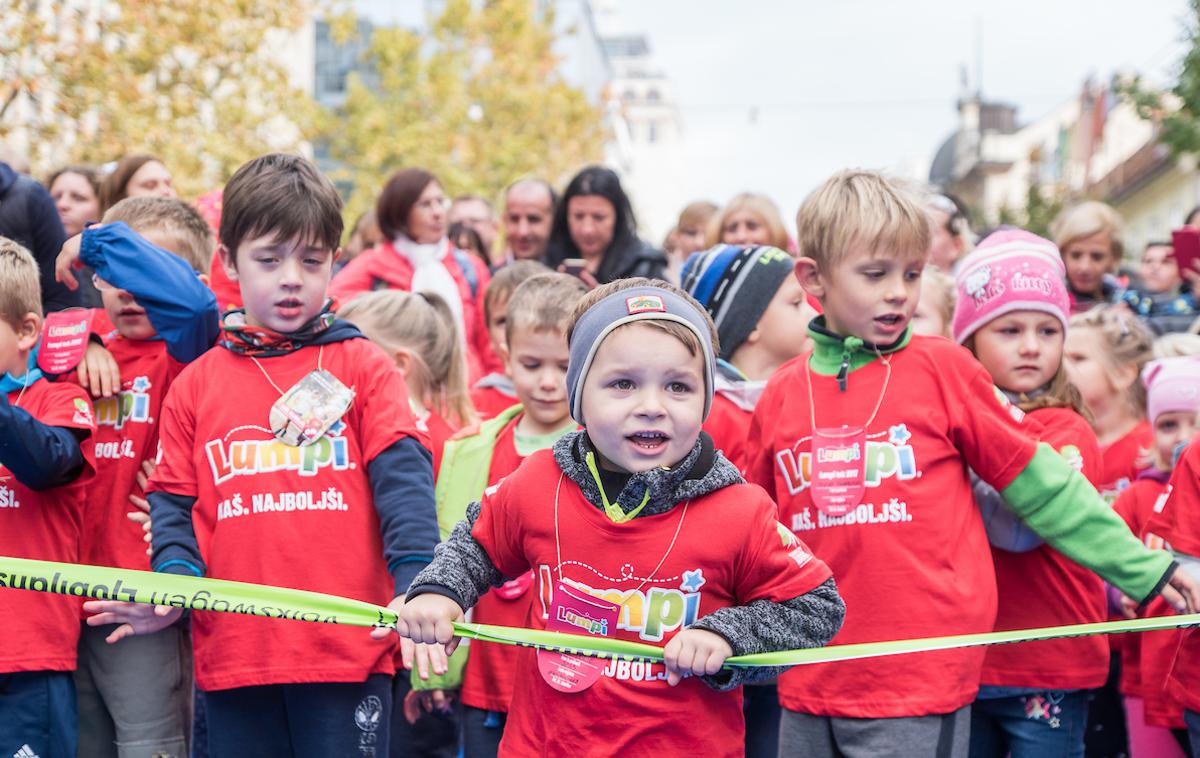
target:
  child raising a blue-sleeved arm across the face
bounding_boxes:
[58,198,217,754]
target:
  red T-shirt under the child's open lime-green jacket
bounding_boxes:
[462,415,533,711]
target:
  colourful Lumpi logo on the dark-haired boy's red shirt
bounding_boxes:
[204,421,352,485]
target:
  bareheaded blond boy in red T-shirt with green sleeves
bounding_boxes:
[748,172,1200,756]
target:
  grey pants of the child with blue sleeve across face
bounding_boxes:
[74,624,192,758]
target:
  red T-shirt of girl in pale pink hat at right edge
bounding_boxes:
[1114,479,1183,729]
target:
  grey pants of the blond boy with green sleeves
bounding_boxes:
[779,705,971,758]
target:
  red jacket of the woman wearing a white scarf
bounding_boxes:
[329,242,504,384]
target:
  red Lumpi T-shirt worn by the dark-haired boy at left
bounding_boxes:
[150,339,425,690]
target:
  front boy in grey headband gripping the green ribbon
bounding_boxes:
[398,278,842,756]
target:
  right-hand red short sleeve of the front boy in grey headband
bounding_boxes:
[734,485,833,606]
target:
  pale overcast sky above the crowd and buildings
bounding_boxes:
[359,0,1188,231]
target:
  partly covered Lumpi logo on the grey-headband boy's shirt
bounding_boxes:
[538,561,706,642]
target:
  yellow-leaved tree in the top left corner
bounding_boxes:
[0,0,318,197]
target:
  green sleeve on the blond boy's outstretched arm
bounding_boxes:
[1001,443,1171,601]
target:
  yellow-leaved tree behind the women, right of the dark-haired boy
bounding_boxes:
[319,0,604,227]
